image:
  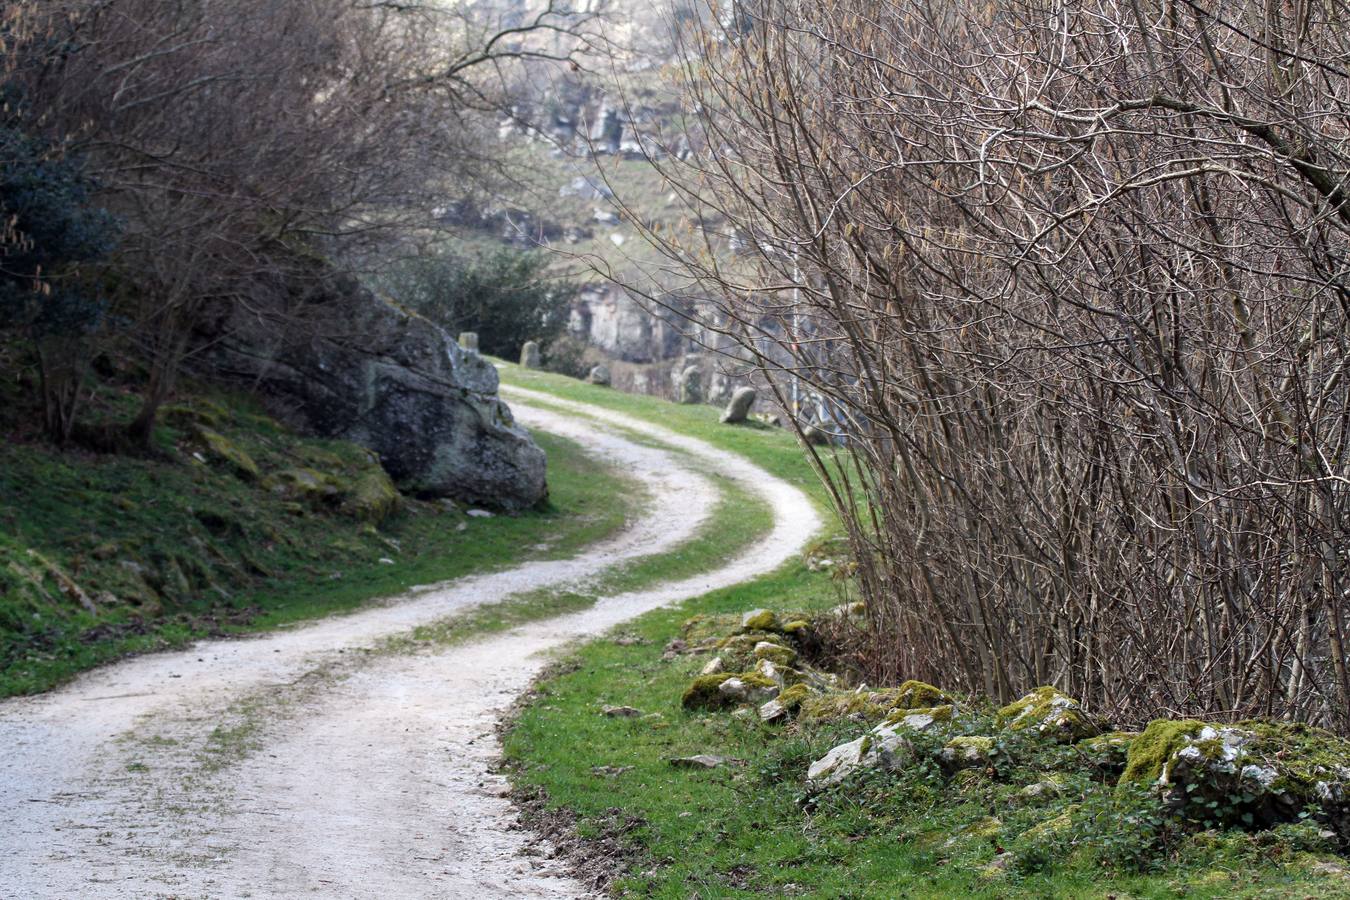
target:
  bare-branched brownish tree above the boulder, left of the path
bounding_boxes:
[0,0,593,447]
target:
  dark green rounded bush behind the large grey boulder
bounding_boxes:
[378,248,576,359]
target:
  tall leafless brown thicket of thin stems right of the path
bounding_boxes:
[637,0,1350,731]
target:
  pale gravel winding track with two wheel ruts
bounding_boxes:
[0,390,819,899]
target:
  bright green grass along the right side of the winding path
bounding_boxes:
[505,368,1350,897]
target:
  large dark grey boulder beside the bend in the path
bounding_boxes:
[197,273,548,510]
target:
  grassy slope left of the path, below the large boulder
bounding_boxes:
[0,388,644,696]
